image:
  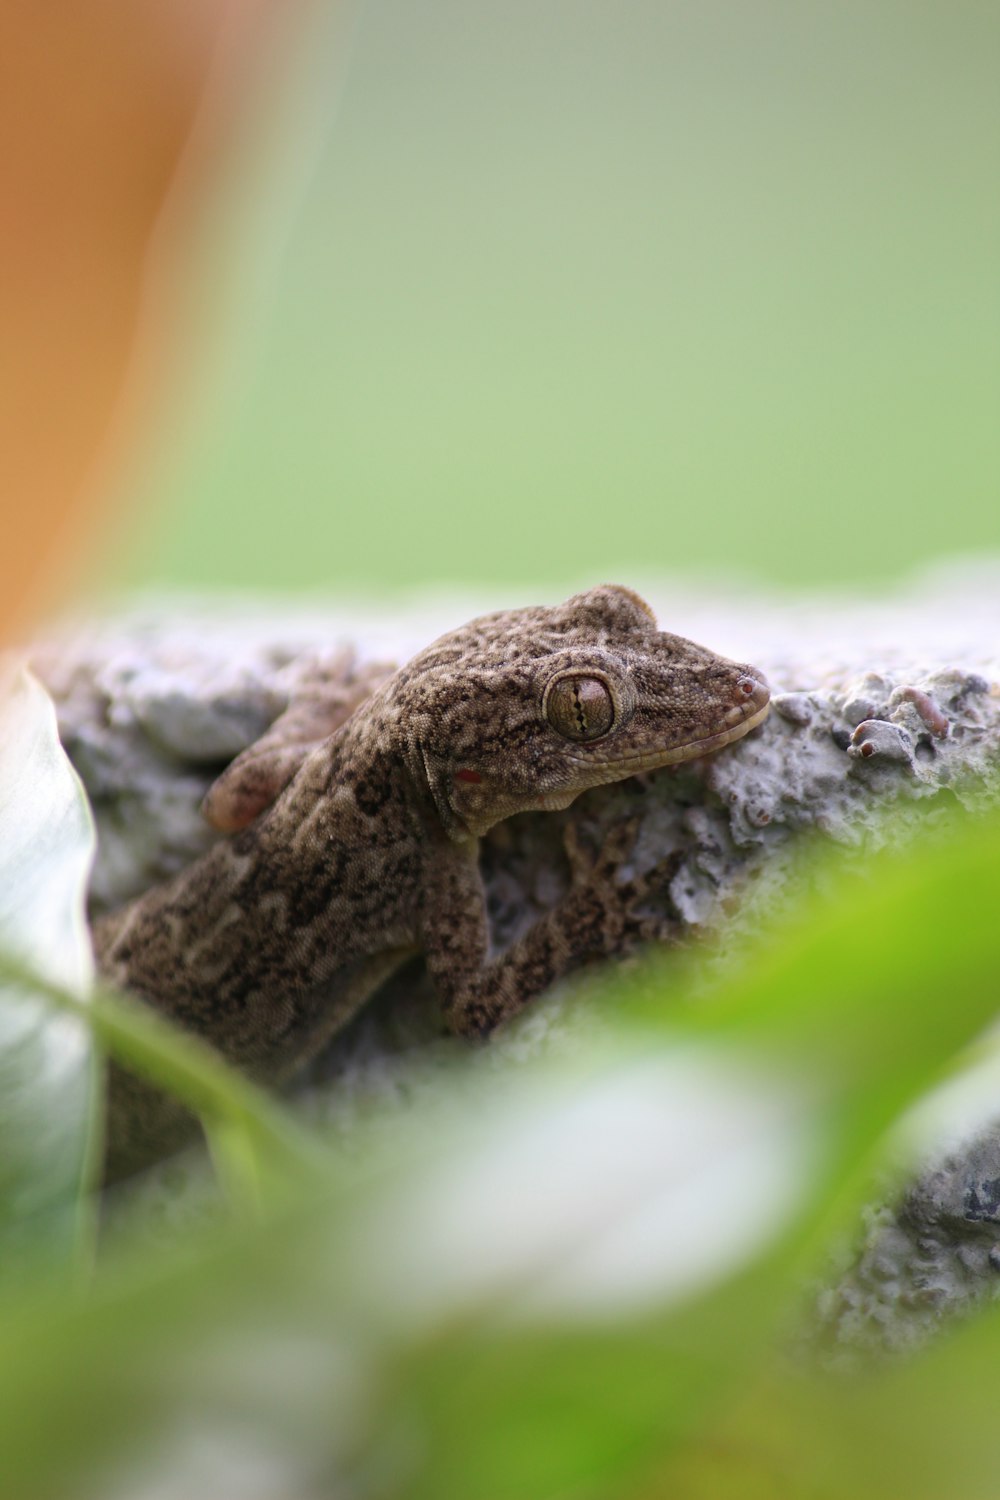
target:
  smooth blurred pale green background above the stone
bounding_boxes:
[103,0,1000,594]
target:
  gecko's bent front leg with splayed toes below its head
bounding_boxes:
[421,821,679,1037]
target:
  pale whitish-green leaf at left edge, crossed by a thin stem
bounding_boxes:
[0,659,94,1269]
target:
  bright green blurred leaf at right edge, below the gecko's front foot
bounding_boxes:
[616,812,1000,1254]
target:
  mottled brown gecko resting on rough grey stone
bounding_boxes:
[93,585,769,1181]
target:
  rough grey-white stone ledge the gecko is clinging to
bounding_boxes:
[31,563,1000,1346]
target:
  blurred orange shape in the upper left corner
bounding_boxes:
[0,0,298,639]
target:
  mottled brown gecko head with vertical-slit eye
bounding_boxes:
[385,585,769,839]
